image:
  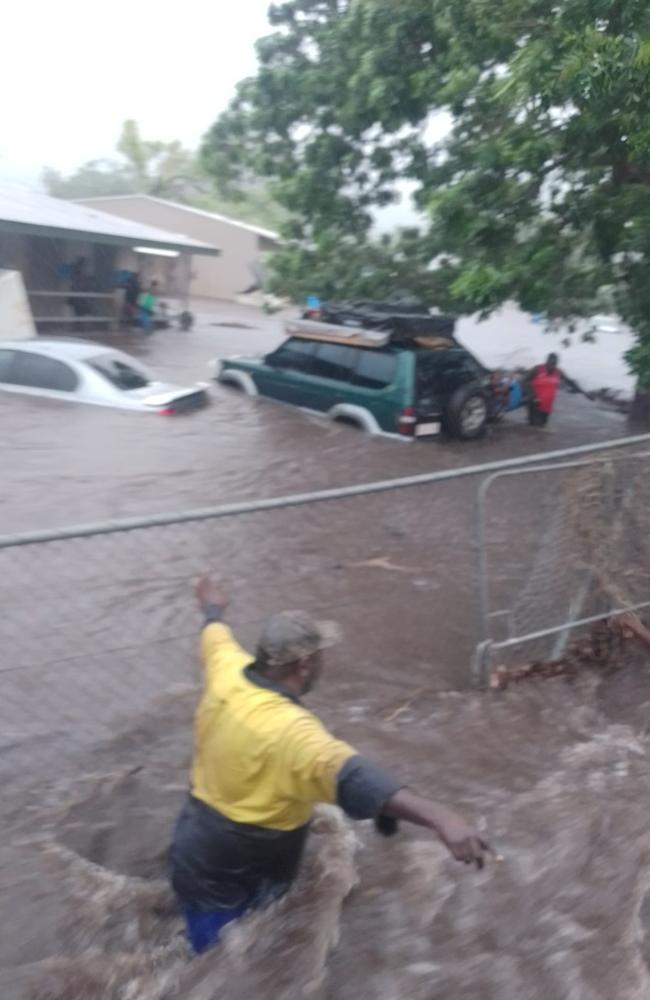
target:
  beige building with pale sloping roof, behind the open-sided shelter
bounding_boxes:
[82,194,281,301]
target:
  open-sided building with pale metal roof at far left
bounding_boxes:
[0,184,220,330]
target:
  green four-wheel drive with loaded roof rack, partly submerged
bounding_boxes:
[216,304,503,439]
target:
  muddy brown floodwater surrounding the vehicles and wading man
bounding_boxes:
[0,306,650,1000]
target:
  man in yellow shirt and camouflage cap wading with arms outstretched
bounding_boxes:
[171,579,489,952]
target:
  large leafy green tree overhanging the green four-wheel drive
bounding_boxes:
[204,0,650,388]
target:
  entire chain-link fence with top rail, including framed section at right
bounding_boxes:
[0,430,650,780]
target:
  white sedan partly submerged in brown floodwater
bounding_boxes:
[0,337,208,414]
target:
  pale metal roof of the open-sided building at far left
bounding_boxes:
[0,182,221,255]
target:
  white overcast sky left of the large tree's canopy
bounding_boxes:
[0,0,270,185]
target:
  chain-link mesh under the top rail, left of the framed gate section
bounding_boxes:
[0,480,480,779]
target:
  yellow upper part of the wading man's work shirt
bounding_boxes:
[192,623,357,830]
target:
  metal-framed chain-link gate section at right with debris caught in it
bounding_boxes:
[474,449,650,684]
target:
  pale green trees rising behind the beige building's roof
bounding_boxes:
[42,120,286,228]
